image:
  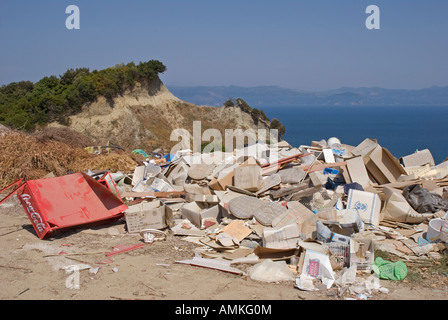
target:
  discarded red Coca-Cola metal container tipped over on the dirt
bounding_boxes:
[17,173,127,239]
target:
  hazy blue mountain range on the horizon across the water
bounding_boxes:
[168,86,448,107]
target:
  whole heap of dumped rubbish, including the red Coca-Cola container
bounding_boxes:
[0,138,448,297]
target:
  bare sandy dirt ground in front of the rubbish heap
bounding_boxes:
[0,197,448,303]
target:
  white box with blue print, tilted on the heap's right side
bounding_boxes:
[347,189,381,226]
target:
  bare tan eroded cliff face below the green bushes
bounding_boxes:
[58,79,270,151]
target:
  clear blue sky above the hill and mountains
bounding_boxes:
[0,0,448,90]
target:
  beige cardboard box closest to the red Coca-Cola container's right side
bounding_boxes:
[125,200,173,233]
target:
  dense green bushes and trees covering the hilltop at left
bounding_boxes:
[0,60,166,130]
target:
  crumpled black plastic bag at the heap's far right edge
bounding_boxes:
[403,184,448,213]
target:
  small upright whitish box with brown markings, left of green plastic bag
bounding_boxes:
[350,239,375,273]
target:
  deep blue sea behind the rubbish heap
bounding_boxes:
[259,106,448,164]
